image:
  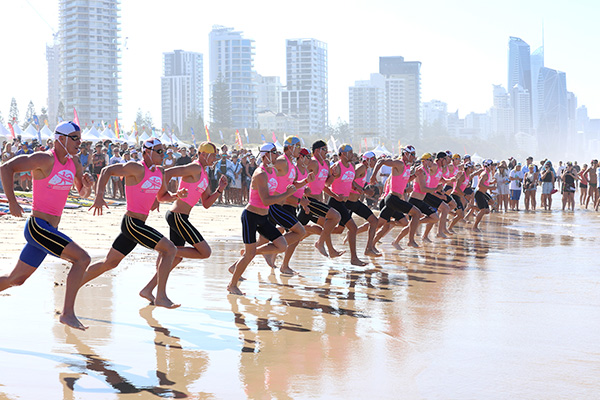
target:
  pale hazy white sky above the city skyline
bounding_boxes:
[0,0,600,128]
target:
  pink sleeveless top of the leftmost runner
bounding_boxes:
[33,150,75,217]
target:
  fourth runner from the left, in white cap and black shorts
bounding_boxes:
[227,143,297,295]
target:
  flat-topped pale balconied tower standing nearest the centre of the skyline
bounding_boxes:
[281,39,329,135]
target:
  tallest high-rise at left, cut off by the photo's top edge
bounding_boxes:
[58,0,121,124]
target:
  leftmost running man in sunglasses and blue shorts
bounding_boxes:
[0,122,93,330]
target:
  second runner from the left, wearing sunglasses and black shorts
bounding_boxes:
[83,138,180,308]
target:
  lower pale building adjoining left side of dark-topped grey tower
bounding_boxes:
[349,74,386,135]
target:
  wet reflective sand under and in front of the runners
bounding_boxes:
[0,207,600,400]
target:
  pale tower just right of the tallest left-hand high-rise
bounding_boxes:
[160,50,204,133]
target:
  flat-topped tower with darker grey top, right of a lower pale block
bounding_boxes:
[379,56,421,138]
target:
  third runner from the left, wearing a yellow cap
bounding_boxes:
[140,142,227,302]
